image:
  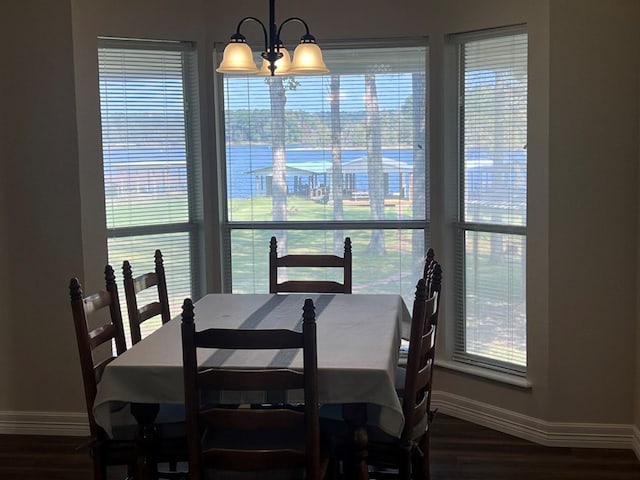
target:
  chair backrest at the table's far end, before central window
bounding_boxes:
[269,237,352,293]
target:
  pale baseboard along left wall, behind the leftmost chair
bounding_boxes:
[0,411,89,437]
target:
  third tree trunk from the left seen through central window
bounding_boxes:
[364,73,385,255]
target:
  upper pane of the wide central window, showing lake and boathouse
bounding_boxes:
[224,47,426,221]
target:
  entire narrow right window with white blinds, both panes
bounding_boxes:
[454,29,527,374]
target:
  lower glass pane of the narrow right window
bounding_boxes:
[464,232,527,366]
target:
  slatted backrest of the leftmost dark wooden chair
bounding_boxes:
[69,265,127,436]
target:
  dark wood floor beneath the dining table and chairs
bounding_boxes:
[0,414,640,480]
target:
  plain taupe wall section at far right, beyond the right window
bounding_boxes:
[549,1,640,423]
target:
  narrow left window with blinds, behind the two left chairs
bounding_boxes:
[98,39,201,342]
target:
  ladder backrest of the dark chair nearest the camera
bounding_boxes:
[182,299,320,480]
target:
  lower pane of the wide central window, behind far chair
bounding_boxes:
[231,229,425,305]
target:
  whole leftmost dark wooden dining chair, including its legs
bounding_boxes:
[69,265,137,480]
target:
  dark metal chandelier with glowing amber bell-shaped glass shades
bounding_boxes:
[216,0,329,76]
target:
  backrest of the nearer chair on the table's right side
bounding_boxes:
[401,278,437,442]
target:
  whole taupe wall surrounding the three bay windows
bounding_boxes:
[0,0,640,446]
